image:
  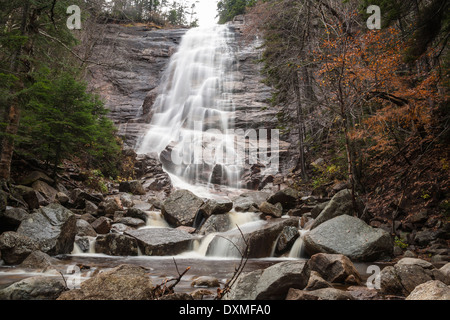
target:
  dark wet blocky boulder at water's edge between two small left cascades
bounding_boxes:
[95,233,138,256]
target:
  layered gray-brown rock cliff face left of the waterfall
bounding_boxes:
[89,25,186,147]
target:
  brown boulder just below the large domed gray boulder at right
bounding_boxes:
[308,253,361,283]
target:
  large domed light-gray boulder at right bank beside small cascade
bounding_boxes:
[303,215,393,261]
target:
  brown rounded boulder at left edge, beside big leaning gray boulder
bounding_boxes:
[0,231,39,265]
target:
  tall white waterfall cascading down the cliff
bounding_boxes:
[137,26,242,187]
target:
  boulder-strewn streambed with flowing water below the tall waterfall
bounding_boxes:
[0,162,450,300]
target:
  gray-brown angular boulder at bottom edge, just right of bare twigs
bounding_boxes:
[224,261,310,300]
